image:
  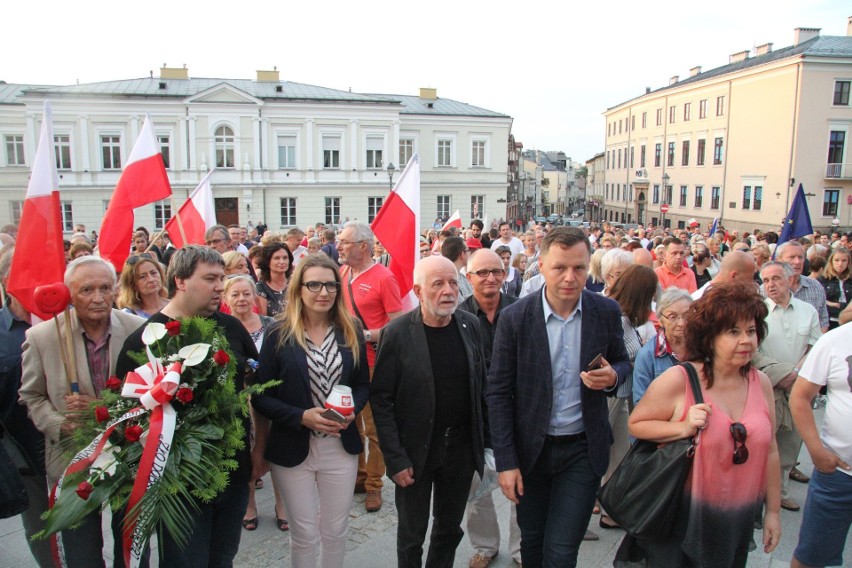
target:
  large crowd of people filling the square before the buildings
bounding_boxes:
[0,215,852,568]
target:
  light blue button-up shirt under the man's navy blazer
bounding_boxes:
[541,287,585,436]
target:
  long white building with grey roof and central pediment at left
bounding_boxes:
[0,67,512,232]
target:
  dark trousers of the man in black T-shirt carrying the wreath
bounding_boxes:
[160,481,249,568]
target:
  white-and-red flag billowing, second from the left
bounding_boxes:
[98,116,172,272]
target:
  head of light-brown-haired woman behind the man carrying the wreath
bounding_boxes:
[115,252,169,318]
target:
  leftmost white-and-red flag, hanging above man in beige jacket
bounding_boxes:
[6,101,65,320]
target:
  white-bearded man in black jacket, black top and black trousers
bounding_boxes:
[370,256,485,568]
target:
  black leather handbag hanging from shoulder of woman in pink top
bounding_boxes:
[598,363,704,540]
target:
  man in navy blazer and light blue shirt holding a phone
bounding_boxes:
[485,227,630,568]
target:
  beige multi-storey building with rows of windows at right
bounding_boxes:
[595,18,852,231]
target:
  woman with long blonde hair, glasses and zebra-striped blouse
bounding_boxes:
[252,255,370,568]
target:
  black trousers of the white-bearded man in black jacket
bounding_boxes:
[396,430,474,568]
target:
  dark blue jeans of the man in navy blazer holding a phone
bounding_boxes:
[518,435,601,568]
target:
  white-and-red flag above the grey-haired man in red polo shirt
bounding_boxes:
[371,154,420,298]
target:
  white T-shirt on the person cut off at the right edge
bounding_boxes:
[799,324,852,475]
